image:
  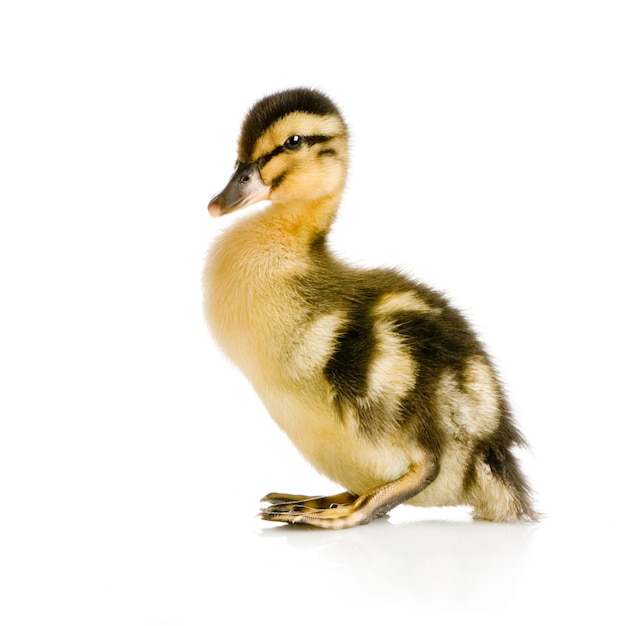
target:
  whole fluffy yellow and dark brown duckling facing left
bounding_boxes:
[203,88,536,529]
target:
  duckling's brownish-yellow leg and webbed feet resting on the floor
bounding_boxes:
[261,463,437,529]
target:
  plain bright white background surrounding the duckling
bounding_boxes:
[0,0,626,626]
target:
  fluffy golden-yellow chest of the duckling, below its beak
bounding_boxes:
[203,215,308,379]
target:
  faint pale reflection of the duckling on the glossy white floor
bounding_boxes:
[260,520,535,610]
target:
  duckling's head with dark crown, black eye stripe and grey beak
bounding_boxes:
[209,88,348,217]
